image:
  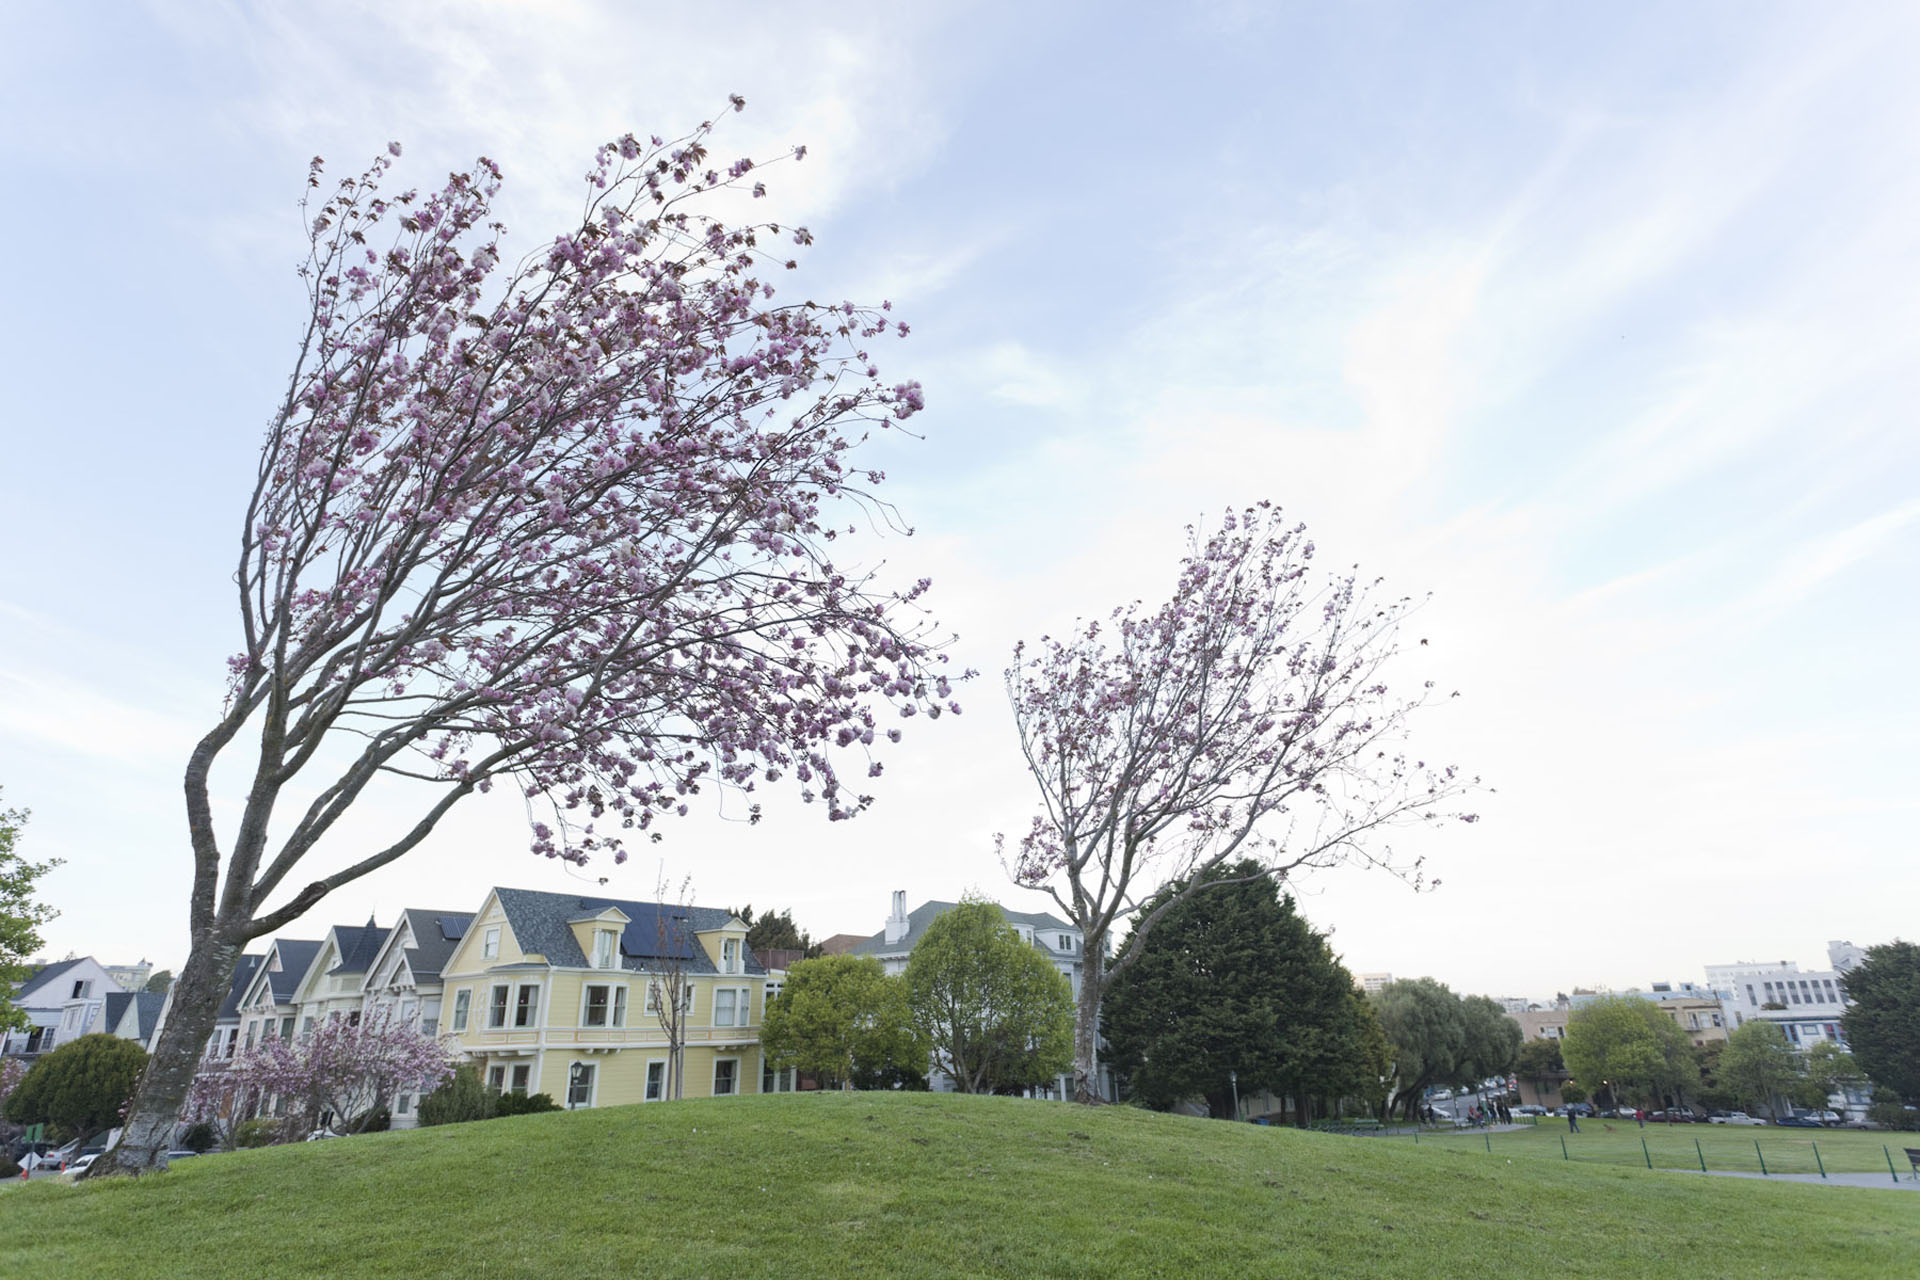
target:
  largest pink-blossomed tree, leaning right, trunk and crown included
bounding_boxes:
[113,98,950,1173]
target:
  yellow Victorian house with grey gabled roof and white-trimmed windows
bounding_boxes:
[440,889,793,1107]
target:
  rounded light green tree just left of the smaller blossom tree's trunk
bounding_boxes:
[906,898,1073,1094]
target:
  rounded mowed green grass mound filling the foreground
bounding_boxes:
[0,1094,1920,1280]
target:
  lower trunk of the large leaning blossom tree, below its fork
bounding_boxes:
[88,929,240,1176]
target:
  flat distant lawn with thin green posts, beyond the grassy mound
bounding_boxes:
[1400,1119,1920,1174]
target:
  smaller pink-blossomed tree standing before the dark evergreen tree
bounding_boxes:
[1000,503,1476,1102]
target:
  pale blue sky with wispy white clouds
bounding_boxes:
[0,0,1920,996]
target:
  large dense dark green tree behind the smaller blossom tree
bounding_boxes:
[1100,862,1384,1117]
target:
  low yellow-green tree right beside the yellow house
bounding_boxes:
[760,956,927,1088]
